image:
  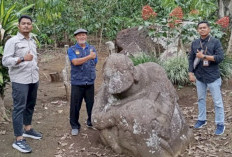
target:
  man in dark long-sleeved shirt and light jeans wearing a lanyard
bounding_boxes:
[189,21,225,135]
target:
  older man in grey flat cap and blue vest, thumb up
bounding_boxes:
[68,29,98,135]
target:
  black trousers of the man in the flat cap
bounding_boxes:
[70,85,94,129]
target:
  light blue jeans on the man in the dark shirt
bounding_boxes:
[196,78,224,124]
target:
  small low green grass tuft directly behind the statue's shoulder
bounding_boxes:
[130,53,159,66]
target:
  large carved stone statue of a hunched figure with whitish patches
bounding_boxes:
[93,54,192,157]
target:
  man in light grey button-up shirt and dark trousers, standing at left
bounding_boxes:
[2,15,42,153]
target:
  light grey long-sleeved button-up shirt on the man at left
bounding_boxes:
[2,33,39,84]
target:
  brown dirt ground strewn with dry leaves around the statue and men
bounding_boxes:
[0,42,232,157]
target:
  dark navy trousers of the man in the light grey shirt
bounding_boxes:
[12,82,39,137]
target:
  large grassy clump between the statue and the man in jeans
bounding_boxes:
[161,56,190,86]
